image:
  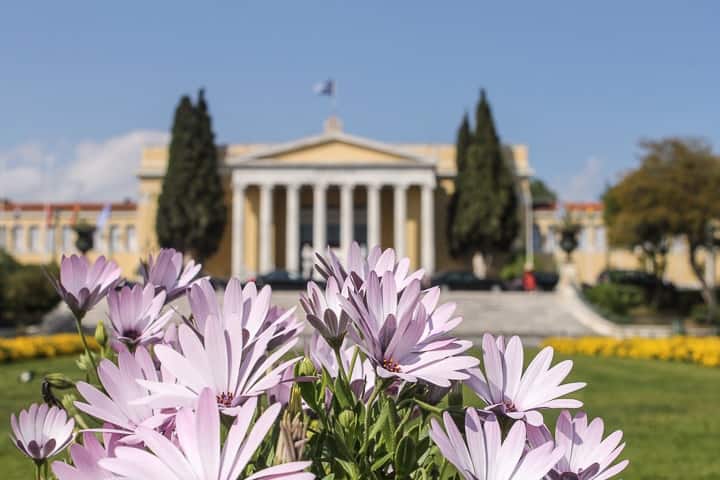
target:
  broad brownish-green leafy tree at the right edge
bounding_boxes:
[603,138,720,318]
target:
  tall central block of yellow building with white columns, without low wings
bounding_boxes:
[138,117,530,278]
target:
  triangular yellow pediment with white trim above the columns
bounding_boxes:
[226,132,435,167]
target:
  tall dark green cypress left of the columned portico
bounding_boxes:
[156,90,227,261]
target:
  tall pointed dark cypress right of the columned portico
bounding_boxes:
[450,90,520,271]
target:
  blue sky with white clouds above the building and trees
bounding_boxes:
[0,1,720,200]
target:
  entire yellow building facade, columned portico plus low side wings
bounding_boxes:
[0,118,712,287]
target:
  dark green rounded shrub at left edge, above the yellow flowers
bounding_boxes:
[0,264,60,326]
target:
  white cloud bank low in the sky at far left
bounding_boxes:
[0,130,169,201]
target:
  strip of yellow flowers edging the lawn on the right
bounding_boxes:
[543,337,720,367]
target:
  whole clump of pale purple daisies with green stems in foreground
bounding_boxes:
[11,244,627,480]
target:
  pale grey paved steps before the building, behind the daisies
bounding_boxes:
[60,292,593,343]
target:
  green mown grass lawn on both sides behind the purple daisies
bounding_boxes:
[0,352,720,480]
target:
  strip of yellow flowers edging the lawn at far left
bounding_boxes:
[0,333,98,362]
